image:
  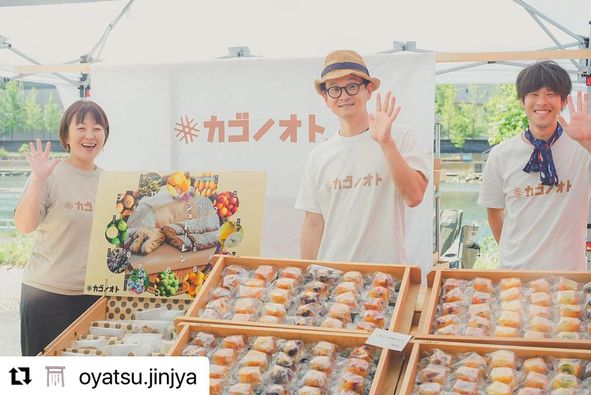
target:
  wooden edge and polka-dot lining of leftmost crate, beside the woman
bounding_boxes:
[39,296,191,356]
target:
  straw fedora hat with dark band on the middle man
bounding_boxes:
[314,49,380,94]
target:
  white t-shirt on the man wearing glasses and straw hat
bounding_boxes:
[295,127,429,264]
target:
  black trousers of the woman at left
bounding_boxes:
[20,284,99,356]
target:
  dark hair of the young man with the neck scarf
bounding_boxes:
[515,60,572,101]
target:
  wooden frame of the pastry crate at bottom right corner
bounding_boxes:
[397,340,591,395]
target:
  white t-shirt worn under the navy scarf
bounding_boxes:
[478,133,591,271]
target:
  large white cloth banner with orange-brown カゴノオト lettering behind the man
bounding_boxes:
[92,54,435,273]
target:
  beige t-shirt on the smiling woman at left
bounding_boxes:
[23,161,100,295]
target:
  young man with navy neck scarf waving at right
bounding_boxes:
[478,61,591,271]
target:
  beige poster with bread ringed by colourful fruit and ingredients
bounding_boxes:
[85,171,266,298]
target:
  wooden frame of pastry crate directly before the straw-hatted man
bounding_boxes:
[177,256,421,333]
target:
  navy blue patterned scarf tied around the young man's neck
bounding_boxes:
[523,124,562,186]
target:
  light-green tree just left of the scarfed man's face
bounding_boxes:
[485,84,527,145]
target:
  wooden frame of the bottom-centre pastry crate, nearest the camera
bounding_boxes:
[171,322,410,395]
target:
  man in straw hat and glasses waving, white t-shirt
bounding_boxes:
[296,50,429,264]
